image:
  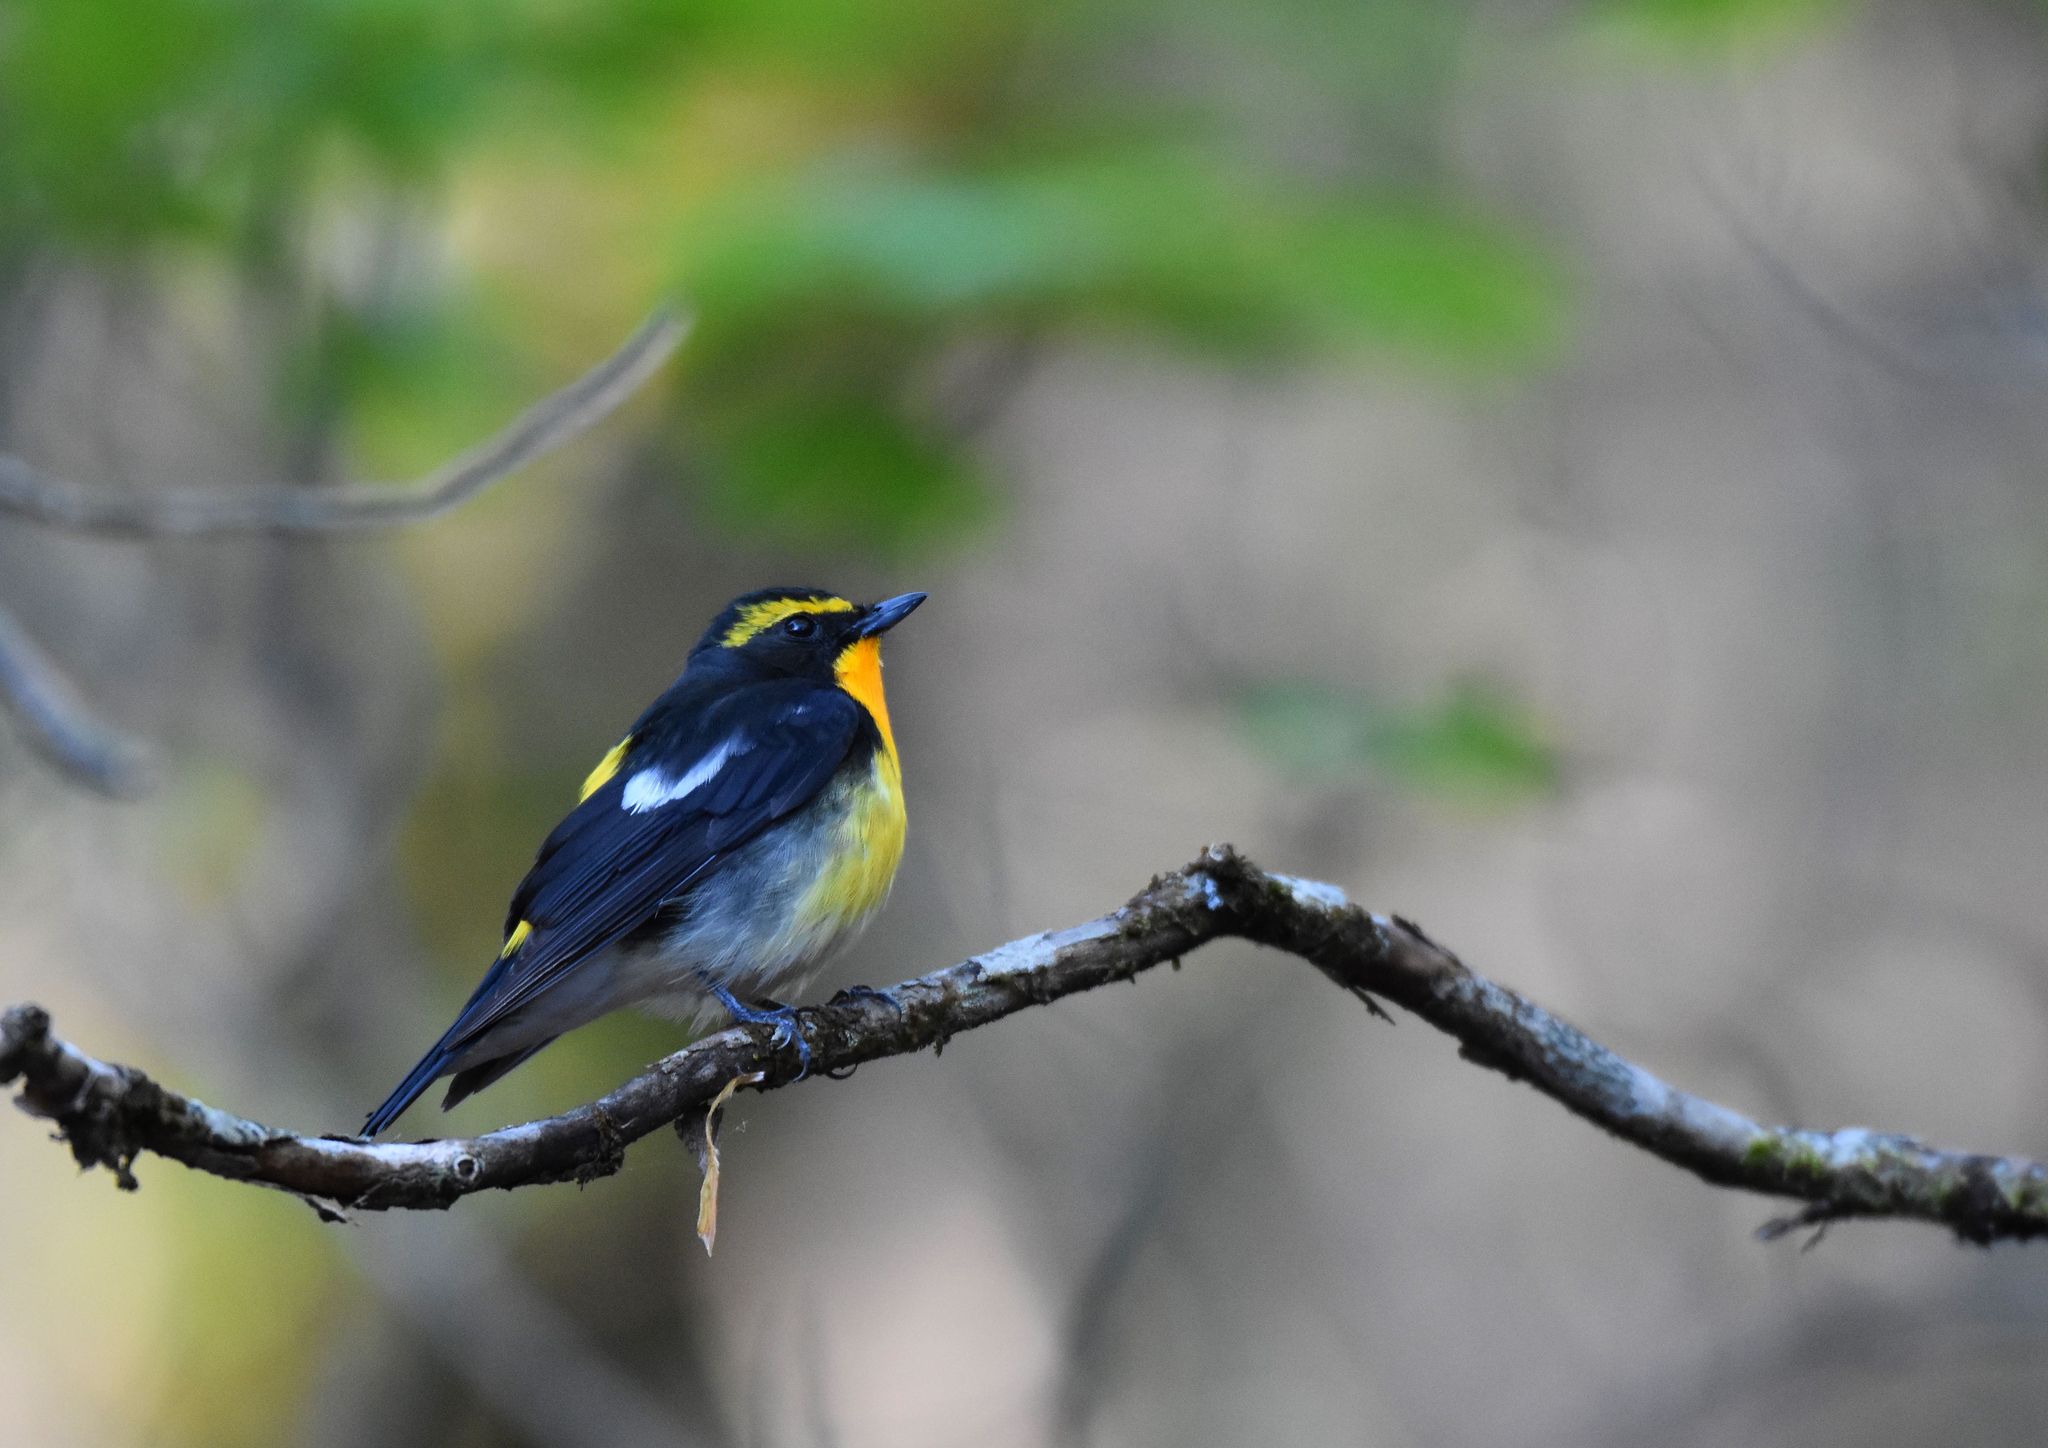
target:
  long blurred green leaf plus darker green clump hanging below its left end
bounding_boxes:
[684,145,1561,543]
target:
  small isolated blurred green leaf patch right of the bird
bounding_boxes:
[1239,682,1563,809]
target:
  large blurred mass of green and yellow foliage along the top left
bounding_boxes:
[0,0,1563,551]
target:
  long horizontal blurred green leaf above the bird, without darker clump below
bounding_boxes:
[682,147,1563,365]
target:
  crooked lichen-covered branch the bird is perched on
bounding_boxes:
[0,846,2048,1243]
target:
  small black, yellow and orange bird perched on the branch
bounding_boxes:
[362,588,924,1137]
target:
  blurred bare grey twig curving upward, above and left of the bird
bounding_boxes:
[0,309,688,539]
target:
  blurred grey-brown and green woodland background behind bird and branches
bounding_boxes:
[0,0,2048,1448]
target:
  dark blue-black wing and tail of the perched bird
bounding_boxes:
[367,680,872,1135]
